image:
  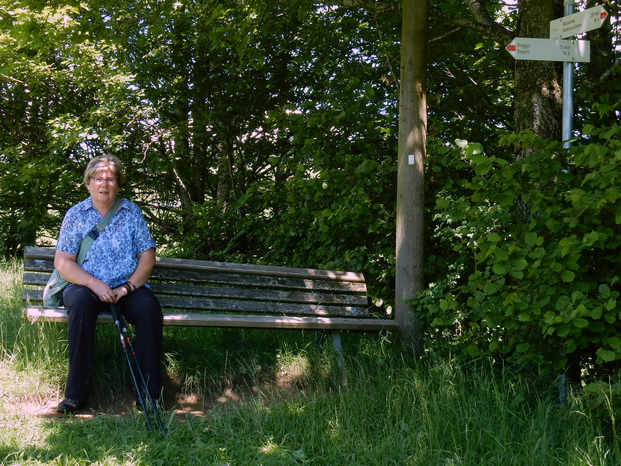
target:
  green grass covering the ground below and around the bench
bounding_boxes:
[0,263,621,466]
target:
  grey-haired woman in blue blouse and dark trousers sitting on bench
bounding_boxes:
[54,155,162,414]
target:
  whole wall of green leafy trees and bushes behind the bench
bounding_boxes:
[0,0,621,378]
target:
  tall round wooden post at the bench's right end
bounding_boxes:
[395,0,427,354]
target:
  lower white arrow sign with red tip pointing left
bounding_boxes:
[506,37,591,62]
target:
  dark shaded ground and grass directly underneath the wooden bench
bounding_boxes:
[34,325,360,416]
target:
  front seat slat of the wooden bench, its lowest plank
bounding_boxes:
[24,306,396,331]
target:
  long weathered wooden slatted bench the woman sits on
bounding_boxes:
[22,246,397,359]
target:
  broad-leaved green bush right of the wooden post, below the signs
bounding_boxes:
[416,93,621,369]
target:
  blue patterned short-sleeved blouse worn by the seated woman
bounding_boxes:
[56,197,155,288]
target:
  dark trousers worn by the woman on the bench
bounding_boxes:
[63,284,162,404]
